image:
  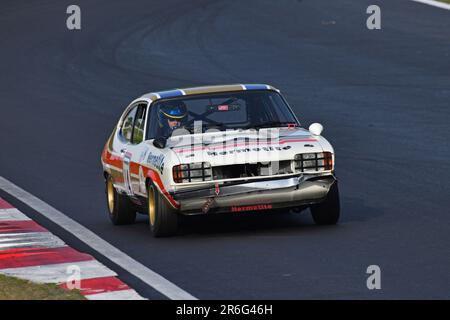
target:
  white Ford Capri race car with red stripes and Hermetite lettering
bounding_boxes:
[101,84,340,237]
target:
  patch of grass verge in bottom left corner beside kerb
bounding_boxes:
[0,275,86,300]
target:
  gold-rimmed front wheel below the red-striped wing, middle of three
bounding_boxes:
[147,183,178,237]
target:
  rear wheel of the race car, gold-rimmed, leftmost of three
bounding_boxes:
[106,176,136,225]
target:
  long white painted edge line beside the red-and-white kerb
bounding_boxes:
[0,177,196,300]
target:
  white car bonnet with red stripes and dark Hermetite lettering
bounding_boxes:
[167,128,324,166]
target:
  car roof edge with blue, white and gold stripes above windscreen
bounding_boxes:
[141,84,279,101]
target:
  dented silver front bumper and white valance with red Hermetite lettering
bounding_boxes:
[171,174,336,214]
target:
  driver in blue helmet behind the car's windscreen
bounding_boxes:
[158,101,187,137]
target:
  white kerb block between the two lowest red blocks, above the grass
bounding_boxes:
[0,260,116,282]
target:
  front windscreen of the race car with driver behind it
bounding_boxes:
[147,90,299,139]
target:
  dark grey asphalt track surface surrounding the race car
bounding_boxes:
[0,0,450,299]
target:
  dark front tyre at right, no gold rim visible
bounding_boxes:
[310,182,341,225]
